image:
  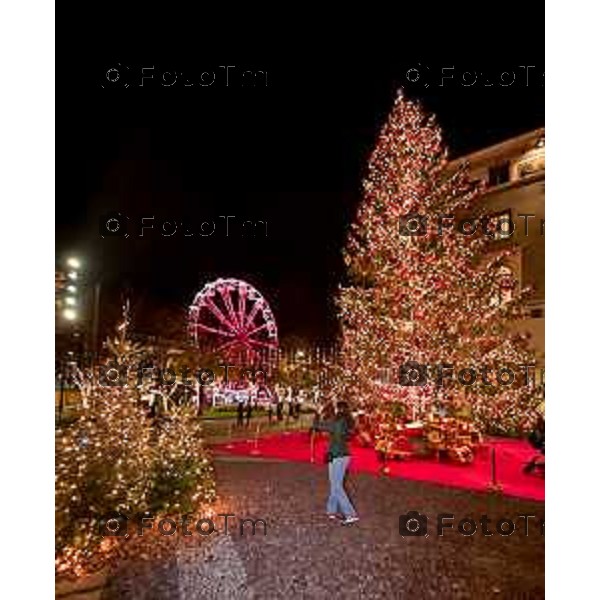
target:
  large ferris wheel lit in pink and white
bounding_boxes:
[188,279,278,365]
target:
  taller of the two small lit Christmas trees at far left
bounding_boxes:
[55,304,153,574]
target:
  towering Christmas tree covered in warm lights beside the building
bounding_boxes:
[338,93,537,431]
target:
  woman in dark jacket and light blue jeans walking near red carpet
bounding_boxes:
[312,402,358,525]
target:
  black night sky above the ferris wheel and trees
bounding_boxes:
[56,17,544,340]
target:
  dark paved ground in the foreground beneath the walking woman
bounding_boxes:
[102,457,544,600]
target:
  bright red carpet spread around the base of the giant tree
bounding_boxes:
[213,432,545,502]
